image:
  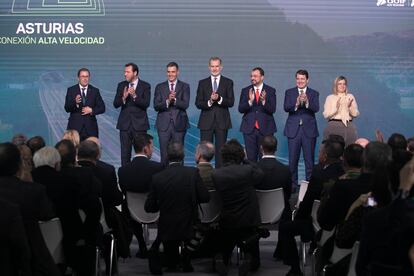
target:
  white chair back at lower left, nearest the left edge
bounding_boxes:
[39,218,65,264]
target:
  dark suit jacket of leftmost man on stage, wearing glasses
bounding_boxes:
[65,84,105,137]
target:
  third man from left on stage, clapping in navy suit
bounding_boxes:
[154,62,190,165]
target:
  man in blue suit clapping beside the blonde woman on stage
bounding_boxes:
[284,70,319,187]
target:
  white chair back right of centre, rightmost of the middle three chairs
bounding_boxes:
[256,188,285,224]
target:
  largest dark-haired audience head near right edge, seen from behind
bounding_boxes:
[363,141,392,172]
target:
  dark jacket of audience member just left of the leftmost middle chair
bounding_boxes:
[78,160,123,208]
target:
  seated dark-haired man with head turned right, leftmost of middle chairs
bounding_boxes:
[118,134,163,258]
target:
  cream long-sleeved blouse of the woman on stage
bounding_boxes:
[323,93,359,126]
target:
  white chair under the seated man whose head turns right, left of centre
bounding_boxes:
[126,192,160,244]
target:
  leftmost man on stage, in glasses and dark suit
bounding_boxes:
[65,68,105,141]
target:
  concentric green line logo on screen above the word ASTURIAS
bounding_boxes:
[0,0,105,17]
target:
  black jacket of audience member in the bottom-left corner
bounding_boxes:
[0,199,32,276]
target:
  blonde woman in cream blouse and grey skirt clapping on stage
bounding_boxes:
[323,76,359,146]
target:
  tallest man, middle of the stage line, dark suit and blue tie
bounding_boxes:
[196,57,234,167]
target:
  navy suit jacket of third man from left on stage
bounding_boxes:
[154,80,190,131]
